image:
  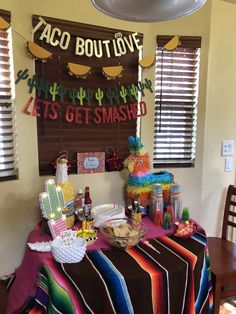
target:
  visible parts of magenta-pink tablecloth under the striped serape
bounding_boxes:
[7,217,173,314]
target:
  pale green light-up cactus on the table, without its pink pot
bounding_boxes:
[39,179,64,220]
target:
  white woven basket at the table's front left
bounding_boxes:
[51,238,86,263]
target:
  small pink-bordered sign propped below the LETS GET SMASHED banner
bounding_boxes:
[77,152,105,174]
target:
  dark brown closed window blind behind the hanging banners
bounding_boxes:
[33,15,142,175]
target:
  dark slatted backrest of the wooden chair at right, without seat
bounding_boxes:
[221,185,236,240]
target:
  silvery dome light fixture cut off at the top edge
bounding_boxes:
[91,0,207,22]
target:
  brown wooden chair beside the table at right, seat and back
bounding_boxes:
[208,185,236,314]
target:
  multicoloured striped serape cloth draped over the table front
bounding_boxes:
[18,232,213,314]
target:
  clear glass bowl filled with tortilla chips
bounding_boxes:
[99,218,147,250]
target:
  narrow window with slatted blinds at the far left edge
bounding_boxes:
[0,10,17,180]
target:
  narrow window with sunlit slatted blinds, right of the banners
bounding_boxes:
[153,36,201,168]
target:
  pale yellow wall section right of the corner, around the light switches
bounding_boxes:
[200,0,236,234]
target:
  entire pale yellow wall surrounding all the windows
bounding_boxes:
[0,0,232,275]
